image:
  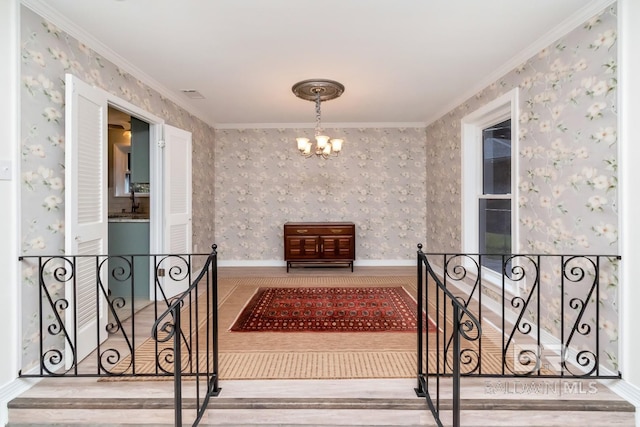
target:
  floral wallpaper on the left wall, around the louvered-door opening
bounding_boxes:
[20,7,214,372]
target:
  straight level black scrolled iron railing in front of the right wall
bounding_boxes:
[418,245,621,426]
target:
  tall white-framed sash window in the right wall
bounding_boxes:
[462,89,518,280]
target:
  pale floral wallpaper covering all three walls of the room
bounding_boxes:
[20,2,618,378]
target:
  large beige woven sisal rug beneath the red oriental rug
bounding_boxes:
[106,276,510,380]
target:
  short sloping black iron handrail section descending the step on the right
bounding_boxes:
[416,244,482,427]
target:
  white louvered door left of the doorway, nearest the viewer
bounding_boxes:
[65,74,108,369]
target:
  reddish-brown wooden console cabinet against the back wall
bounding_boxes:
[284,222,356,272]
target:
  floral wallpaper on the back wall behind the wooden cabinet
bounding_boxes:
[215,128,426,261]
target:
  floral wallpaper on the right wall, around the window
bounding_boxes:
[427,5,619,367]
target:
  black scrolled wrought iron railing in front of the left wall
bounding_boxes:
[19,245,220,425]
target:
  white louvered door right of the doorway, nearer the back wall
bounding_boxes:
[160,125,192,298]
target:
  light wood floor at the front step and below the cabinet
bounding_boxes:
[8,266,635,427]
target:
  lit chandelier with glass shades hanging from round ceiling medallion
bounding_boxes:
[291,79,344,159]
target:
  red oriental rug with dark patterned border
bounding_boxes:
[231,286,435,332]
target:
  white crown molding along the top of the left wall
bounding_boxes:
[20,0,214,127]
